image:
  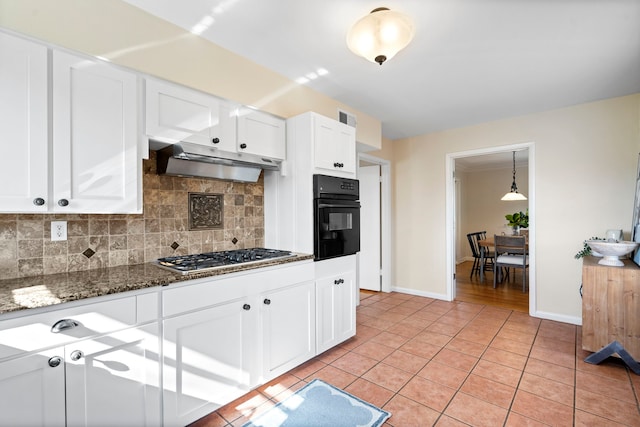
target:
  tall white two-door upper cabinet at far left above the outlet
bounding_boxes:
[0,33,142,213]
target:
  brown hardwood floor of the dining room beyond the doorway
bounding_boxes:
[456,261,529,313]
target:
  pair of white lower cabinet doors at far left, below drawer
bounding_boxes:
[0,323,160,426]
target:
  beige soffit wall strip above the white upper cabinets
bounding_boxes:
[0,0,382,149]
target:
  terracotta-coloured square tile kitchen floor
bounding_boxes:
[194,293,640,427]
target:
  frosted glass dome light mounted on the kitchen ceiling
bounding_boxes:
[347,7,415,65]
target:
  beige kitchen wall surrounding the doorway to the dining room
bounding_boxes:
[393,94,640,321]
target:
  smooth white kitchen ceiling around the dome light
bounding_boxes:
[125,0,640,145]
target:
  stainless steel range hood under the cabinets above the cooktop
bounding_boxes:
[157,142,280,182]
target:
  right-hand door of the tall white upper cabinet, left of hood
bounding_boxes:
[50,51,142,213]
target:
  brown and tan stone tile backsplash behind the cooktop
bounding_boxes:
[0,152,264,279]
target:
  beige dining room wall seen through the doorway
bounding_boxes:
[456,166,529,261]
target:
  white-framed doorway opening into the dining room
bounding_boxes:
[446,142,536,313]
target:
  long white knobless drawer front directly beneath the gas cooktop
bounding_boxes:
[162,261,314,317]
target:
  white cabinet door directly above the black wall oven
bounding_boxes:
[313,115,356,176]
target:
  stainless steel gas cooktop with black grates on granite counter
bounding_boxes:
[156,248,295,274]
